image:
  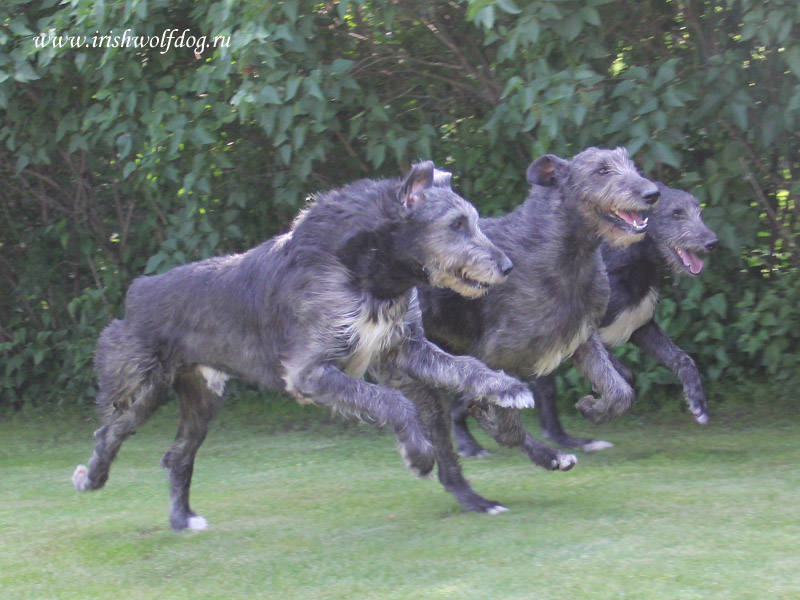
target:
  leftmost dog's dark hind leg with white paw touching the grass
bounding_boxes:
[161,366,227,530]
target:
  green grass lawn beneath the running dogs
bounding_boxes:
[0,390,800,600]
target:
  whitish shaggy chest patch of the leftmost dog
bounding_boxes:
[344,300,408,377]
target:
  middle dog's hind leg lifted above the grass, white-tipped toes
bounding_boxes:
[469,400,578,471]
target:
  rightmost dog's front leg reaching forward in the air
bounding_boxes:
[631,319,708,425]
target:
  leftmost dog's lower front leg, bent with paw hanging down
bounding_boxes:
[286,363,434,477]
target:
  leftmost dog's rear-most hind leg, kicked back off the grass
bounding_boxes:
[72,321,164,492]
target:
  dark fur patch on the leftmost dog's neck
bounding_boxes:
[337,223,428,300]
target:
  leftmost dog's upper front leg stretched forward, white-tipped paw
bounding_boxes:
[390,339,534,408]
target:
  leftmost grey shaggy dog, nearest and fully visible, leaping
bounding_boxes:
[72,162,533,529]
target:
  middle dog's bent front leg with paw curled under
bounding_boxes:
[574,333,636,423]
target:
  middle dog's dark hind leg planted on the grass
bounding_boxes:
[398,382,508,515]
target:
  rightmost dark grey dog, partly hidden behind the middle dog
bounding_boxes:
[520,183,717,454]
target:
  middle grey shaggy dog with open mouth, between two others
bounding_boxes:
[398,148,659,512]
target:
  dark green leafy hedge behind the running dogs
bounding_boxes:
[0,0,800,408]
